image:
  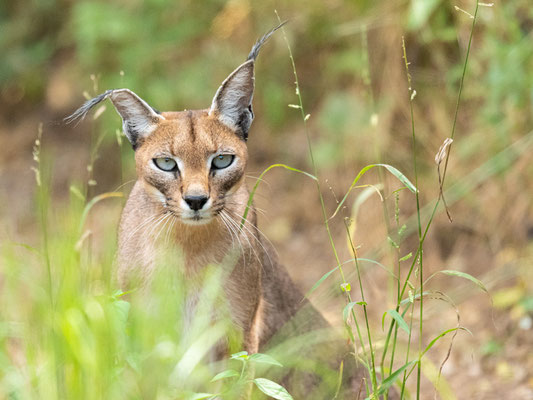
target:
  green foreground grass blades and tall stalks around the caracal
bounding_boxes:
[0,4,530,399]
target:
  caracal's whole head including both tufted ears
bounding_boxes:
[69,25,281,225]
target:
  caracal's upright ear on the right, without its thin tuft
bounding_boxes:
[209,60,254,140]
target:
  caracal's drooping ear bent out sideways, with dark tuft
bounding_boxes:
[65,89,165,149]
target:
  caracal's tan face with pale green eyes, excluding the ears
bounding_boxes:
[135,110,248,225]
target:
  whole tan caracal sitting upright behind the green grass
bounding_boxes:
[67,25,361,399]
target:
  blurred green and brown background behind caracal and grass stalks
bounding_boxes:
[0,0,533,399]
